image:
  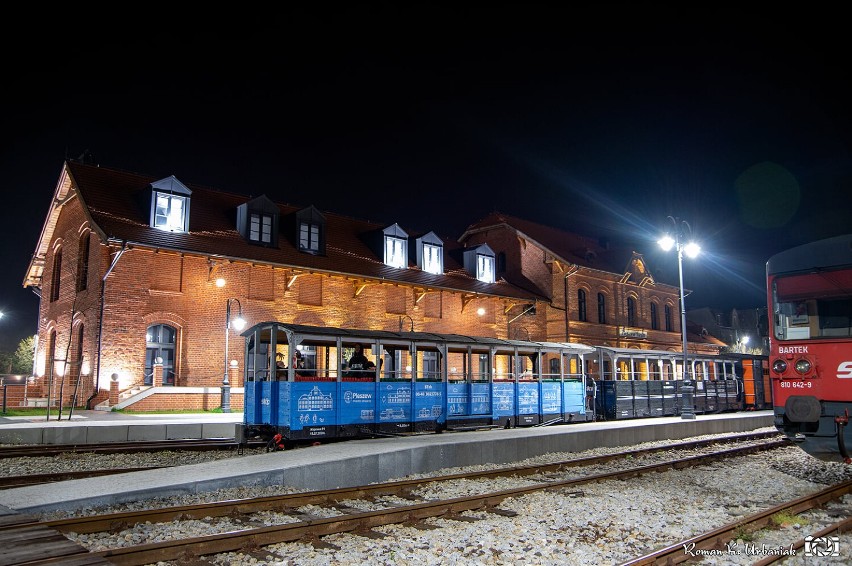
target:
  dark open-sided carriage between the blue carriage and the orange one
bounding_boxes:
[586,346,744,420]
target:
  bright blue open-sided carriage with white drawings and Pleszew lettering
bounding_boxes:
[237,322,594,448]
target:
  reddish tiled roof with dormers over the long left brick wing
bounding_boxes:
[30,161,543,300]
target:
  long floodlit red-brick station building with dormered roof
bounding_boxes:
[24,161,719,410]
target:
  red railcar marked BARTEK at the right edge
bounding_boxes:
[766,234,852,464]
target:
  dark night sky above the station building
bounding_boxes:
[0,6,852,349]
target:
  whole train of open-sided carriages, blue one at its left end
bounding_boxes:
[237,322,762,445]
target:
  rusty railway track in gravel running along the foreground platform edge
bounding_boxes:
[0,434,789,564]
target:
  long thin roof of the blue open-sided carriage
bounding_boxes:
[241,321,595,353]
